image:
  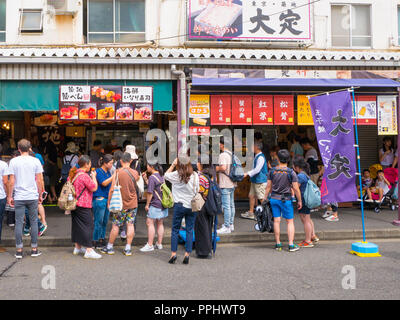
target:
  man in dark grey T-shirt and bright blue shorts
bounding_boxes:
[265,149,302,252]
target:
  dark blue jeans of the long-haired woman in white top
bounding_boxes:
[171,203,196,253]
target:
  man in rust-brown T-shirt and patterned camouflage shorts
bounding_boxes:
[101,152,139,256]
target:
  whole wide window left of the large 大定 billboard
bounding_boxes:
[86,0,145,43]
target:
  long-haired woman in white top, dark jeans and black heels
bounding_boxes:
[164,156,199,264]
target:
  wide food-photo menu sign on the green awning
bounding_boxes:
[59,85,153,121]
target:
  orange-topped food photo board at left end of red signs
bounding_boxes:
[189,94,210,136]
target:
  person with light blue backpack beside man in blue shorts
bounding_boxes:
[293,156,321,248]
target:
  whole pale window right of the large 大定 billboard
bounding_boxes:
[331,4,372,48]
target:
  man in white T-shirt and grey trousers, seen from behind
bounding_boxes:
[8,139,44,259]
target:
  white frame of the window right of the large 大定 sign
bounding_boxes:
[329,2,373,49]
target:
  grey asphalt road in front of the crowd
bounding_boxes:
[0,241,400,300]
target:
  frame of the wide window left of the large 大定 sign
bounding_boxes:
[84,0,147,44]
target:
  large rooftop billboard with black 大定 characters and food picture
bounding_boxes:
[187,0,311,41]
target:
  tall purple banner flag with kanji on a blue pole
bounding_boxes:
[309,90,358,203]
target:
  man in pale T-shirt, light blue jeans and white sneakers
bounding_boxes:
[216,139,236,234]
